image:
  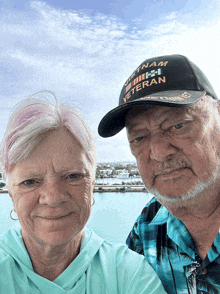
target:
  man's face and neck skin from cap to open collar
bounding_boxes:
[126,98,220,259]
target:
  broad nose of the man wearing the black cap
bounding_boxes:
[150,132,177,162]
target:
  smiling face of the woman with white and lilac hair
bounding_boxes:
[8,129,94,245]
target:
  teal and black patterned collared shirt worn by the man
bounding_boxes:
[126,198,220,294]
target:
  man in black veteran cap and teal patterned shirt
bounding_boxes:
[99,55,220,294]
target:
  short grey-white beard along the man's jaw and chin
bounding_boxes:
[147,162,220,202]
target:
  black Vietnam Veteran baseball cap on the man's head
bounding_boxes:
[98,55,218,137]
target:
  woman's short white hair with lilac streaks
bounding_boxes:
[0,96,97,179]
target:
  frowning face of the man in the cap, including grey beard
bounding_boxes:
[126,102,220,201]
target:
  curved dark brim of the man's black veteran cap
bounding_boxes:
[98,90,206,138]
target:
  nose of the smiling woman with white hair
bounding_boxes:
[39,180,69,207]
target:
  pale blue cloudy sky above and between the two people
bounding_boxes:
[0,0,220,162]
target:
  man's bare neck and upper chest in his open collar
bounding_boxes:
[162,191,220,259]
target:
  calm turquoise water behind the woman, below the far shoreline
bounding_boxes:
[0,192,152,243]
